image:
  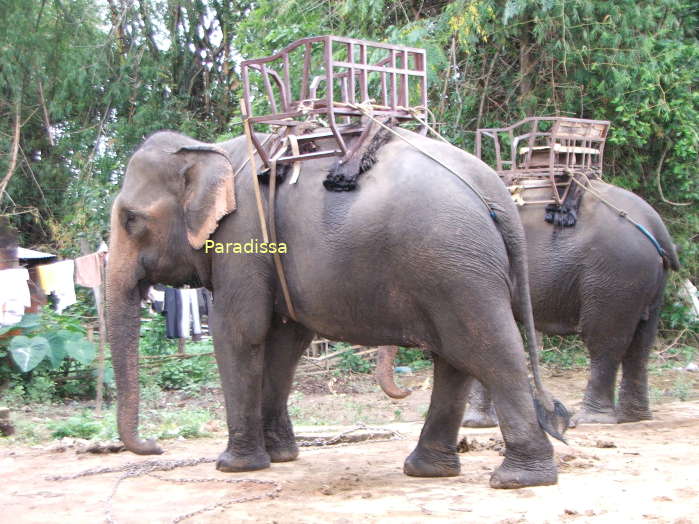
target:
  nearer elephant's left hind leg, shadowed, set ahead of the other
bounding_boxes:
[403,354,468,477]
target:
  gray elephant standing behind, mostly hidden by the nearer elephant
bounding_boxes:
[377,179,679,427]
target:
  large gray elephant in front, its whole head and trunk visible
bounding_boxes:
[107,131,560,488]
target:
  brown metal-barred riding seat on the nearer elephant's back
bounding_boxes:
[241,35,427,167]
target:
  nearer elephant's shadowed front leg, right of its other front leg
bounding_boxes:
[262,318,313,462]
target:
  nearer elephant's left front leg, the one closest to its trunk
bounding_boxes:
[213,314,270,472]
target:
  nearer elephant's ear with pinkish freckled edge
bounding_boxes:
[175,145,236,249]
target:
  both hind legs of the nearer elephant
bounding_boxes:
[404,316,557,488]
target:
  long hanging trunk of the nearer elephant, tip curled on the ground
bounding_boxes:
[106,243,163,455]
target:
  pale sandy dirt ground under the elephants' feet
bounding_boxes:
[0,373,699,524]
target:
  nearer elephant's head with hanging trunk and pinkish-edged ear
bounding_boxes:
[106,131,235,454]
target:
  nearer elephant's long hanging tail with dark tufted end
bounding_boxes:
[498,210,571,442]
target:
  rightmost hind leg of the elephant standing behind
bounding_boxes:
[617,306,660,423]
